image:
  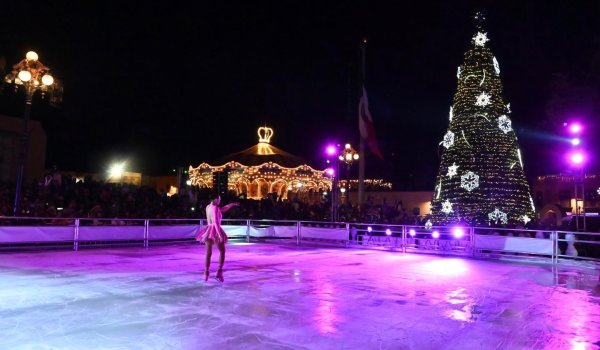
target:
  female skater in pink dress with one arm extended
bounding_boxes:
[196,195,240,282]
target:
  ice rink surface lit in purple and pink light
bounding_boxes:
[0,243,600,350]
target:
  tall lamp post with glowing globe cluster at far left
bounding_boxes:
[4,51,56,216]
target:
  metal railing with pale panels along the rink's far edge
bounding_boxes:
[0,217,600,263]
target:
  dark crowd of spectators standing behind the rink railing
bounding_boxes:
[0,174,420,224]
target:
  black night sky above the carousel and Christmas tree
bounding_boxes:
[0,1,600,190]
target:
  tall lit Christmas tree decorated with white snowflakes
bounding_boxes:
[431,13,535,225]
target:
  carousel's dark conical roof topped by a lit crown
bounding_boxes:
[216,127,306,168]
